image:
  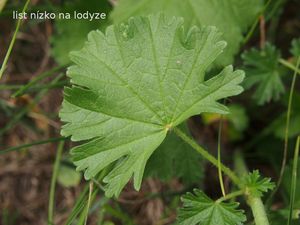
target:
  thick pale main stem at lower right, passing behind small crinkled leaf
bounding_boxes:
[234,151,269,225]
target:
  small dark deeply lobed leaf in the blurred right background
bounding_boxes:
[242,43,284,105]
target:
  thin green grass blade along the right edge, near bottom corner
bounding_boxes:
[287,136,300,225]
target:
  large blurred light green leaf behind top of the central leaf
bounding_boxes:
[111,0,263,66]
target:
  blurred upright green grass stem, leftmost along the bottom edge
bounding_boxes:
[48,141,65,225]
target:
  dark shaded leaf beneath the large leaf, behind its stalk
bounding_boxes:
[145,126,204,184]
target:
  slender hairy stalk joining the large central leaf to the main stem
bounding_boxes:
[173,127,242,188]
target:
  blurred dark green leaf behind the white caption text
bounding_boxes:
[50,0,111,65]
